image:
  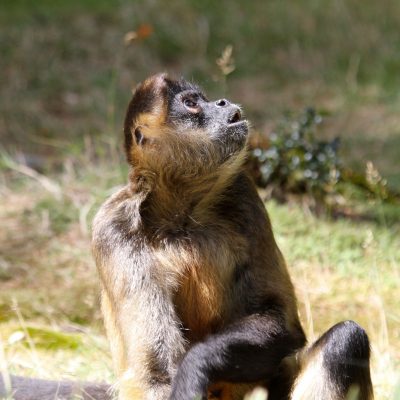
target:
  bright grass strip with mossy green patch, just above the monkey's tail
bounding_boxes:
[0,322,113,382]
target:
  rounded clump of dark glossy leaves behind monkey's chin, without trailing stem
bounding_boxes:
[251,108,341,197]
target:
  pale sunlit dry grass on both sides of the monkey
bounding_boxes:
[0,160,400,400]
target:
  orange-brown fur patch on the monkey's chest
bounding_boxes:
[165,224,248,341]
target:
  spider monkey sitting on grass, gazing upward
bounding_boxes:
[93,74,373,400]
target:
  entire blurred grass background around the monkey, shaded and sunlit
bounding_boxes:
[0,0,400,399]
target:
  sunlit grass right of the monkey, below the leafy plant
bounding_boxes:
[267,202,400,399]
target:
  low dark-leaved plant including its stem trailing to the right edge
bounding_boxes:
[250,108,400,211]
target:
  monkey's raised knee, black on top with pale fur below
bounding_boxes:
[290,321,373,400]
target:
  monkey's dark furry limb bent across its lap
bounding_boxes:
[170,313,304,400]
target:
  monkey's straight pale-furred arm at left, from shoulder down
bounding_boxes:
[93,188,185,400]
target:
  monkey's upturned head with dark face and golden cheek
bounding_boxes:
[124,74,248,178]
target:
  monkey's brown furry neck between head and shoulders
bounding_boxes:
[130,148,247,229]
